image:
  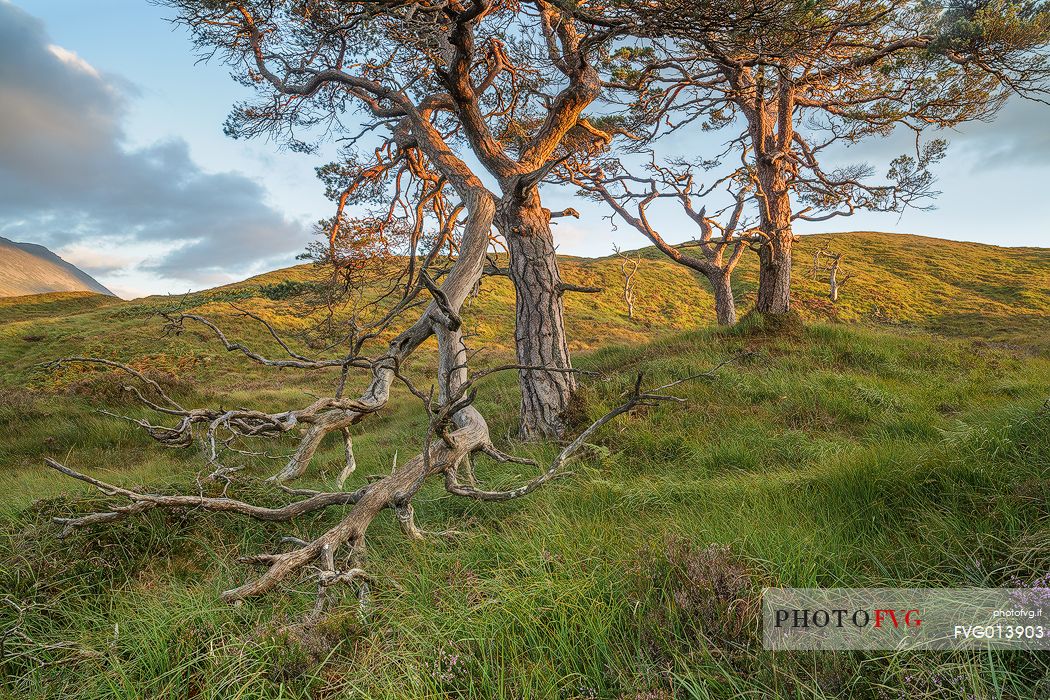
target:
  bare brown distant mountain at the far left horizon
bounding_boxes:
[0,237,117,297]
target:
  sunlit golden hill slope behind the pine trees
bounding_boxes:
[0,233,1050,394]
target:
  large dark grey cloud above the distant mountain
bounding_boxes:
[0,0,307,282]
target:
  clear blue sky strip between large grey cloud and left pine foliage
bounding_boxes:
[15,0,330,220]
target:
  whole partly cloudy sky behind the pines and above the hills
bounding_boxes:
[0,0,1050,298]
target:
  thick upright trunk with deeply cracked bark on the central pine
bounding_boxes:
[500,193,576,440]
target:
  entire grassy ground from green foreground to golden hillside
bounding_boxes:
[0,233,1050,700]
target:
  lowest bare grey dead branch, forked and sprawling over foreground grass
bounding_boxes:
[46,348,729,614]
